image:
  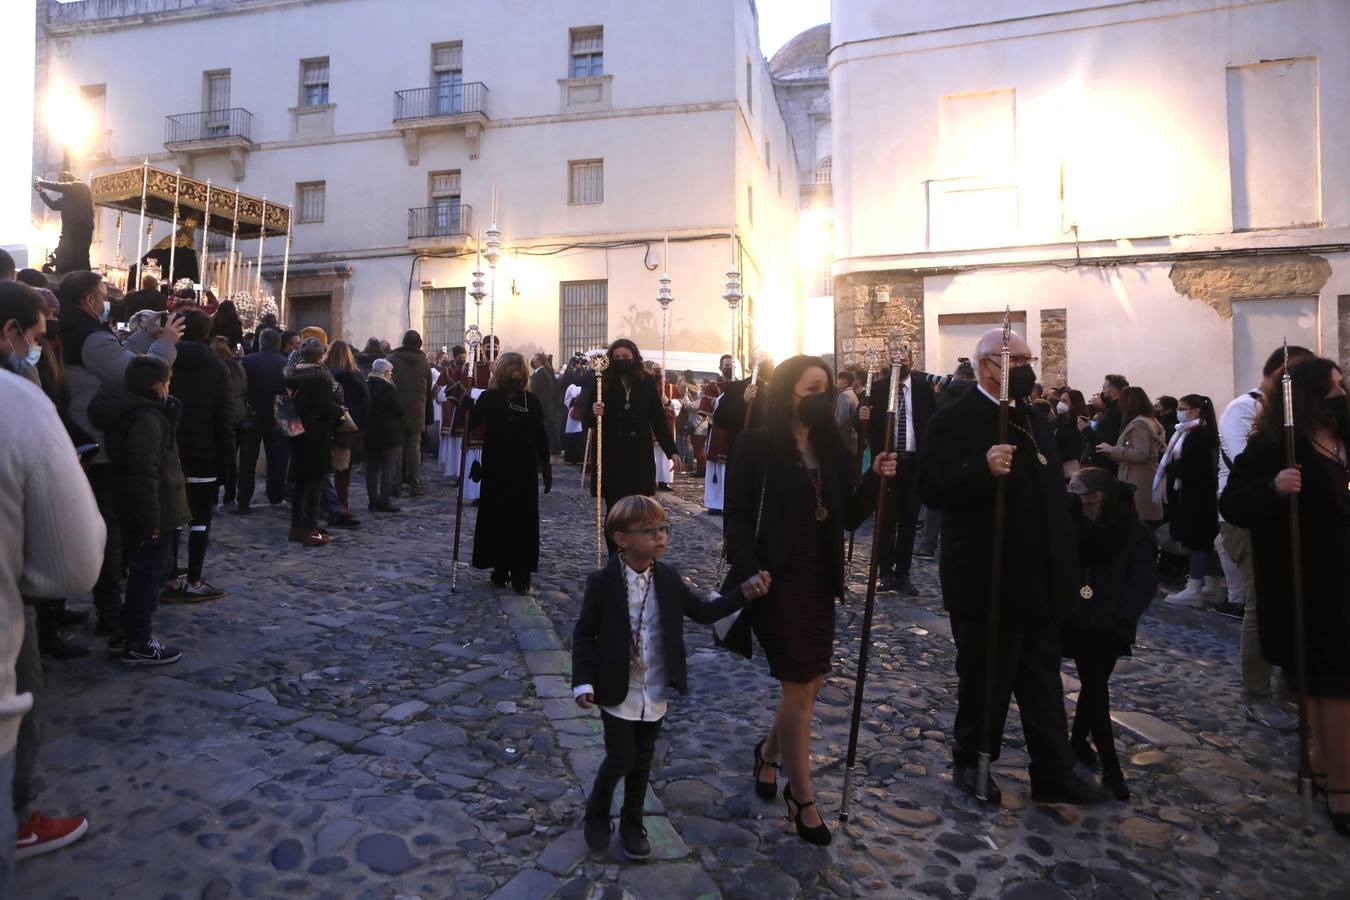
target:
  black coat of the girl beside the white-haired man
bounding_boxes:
[1062,483,1158,658]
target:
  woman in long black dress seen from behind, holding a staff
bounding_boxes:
[460,354,545,594]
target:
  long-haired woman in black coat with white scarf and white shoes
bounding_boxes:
[1153,394,1223,609]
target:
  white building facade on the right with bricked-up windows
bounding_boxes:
[829,0,1350,403]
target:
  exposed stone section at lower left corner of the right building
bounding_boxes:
[834,271,925,368]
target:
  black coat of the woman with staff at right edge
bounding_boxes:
[1220,437,1350,696]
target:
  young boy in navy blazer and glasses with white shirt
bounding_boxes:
[572,497,770,860]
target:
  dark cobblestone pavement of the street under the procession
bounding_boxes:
[15,466,1350,900]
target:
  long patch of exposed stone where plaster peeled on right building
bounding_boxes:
[1169,254,1331,318]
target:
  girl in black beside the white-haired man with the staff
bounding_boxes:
[1061,466,1158,800]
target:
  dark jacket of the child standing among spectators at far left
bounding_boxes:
[89,385,190,546]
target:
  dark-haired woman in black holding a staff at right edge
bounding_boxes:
[1225,359,1350,837]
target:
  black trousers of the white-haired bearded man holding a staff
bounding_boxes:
[952,617,1073,784]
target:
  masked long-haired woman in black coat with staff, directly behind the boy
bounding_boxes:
[583,337,680,550]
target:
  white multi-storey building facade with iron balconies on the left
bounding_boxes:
[34,0,801,369]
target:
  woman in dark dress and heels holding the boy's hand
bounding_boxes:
[724,356,895,843]
